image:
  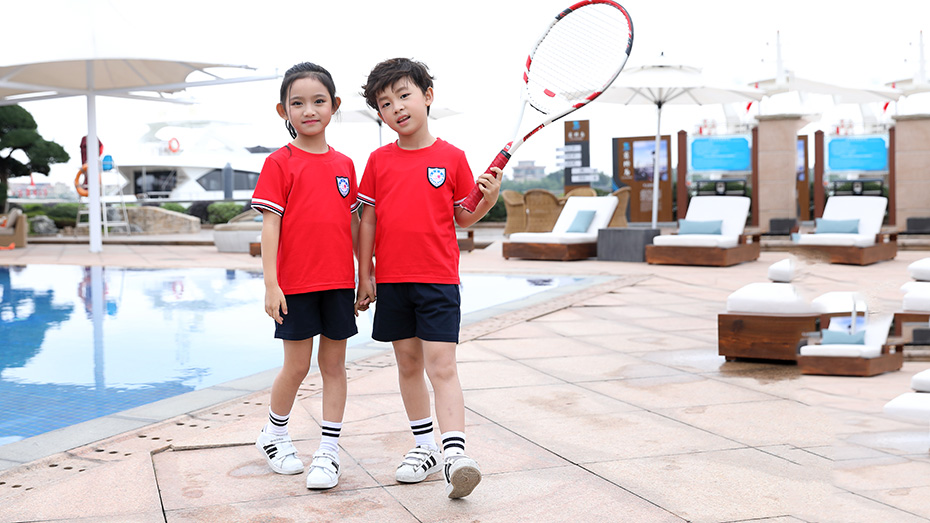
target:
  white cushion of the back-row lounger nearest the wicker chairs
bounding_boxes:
[510,196,617,243]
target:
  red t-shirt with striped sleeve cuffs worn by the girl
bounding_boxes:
[252,146,360,294]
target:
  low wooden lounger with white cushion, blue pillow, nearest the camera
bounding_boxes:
[798,314,904,376]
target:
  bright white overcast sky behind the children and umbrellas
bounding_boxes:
[0,0,930,182]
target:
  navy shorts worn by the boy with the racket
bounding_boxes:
[371,283,462,343]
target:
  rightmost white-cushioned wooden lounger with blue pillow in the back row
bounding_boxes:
[794,196,898,265]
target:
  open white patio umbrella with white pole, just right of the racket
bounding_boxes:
[597,55,763,229]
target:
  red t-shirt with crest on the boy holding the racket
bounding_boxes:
[358,139,475,284]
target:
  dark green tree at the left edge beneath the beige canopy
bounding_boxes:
[0,105,71,209]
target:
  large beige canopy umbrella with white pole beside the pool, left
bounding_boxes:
[0,58,277,253]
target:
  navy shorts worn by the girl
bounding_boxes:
[274,289,358,341]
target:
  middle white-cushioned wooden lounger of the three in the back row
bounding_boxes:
[646,196,760,267]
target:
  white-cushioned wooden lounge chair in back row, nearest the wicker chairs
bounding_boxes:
[502,195,618,261]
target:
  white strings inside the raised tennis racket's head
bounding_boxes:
[527,4,630,114]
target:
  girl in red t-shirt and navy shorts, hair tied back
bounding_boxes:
[252,62,359,489]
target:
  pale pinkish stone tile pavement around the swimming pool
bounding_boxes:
[0,238,930,523]
